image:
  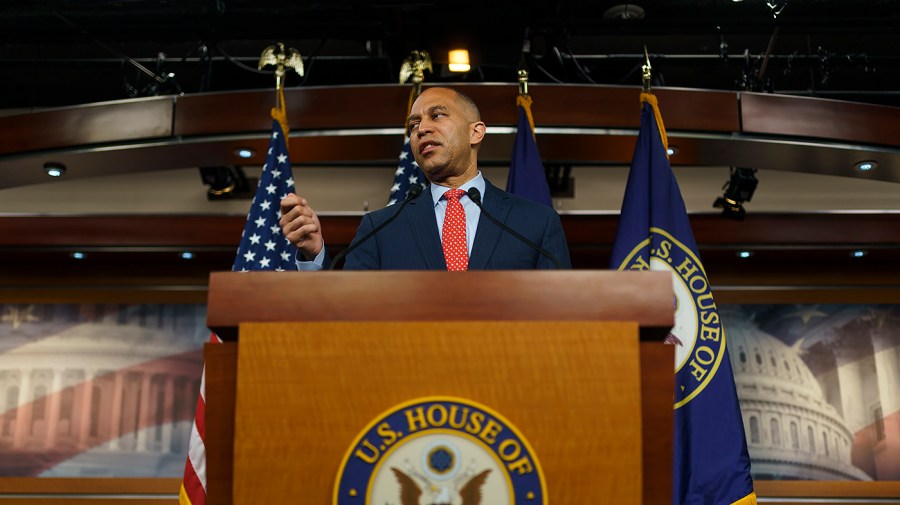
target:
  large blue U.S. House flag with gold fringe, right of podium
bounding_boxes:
[611,94,756,505]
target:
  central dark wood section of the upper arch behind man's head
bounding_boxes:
[174,84,740,136]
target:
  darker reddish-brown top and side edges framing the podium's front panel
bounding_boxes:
[206,270,674,505]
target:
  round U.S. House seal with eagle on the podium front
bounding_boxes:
[333,396,547,505]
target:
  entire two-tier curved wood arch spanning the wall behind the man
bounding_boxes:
[0,84,900,188]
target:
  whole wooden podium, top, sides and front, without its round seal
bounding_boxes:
[206,271,674,505]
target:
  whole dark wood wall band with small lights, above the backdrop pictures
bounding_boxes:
[0,214,900,303]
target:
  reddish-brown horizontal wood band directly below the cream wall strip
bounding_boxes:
[7,212,900,249]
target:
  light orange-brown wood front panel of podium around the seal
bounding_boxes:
[234,322,642,505]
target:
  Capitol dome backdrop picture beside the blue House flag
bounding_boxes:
[722,306,900,480]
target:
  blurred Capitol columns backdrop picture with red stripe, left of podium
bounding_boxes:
[0,305,208,477]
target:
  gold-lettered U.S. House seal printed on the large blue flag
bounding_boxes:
[619,227,725,408]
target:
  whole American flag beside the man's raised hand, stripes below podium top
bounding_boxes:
[178,116,297,505]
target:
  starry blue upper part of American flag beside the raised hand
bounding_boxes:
[232,120,297,272]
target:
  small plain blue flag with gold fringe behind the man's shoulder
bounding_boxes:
[506,95,553,207]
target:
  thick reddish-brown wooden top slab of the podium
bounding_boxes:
[207,270,674,340]
